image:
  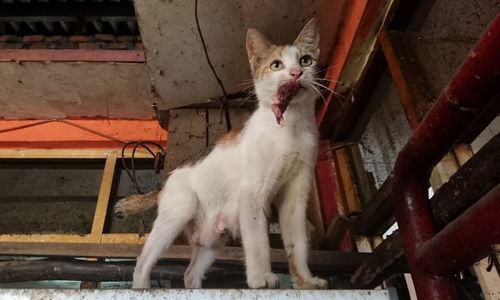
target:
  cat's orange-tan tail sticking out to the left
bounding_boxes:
[114,190,160,218]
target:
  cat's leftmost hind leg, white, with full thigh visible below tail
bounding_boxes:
[132,173,197,288]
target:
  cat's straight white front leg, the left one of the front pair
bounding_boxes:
[239,192,279,289]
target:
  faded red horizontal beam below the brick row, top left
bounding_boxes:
[0,49,146,63]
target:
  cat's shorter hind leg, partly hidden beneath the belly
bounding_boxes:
[184,245,216,289]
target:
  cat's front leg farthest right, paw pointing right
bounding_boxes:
[278,170,328,289]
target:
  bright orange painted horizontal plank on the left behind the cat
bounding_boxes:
[0,119,168,149]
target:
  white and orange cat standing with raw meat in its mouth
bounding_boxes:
[116,20,328,289]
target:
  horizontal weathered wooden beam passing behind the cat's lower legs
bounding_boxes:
[0,242,368,273]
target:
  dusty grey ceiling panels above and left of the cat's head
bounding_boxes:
[0,0,344,119]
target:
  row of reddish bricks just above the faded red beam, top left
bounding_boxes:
[0,34,143,50]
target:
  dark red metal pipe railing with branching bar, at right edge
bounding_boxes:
[392,15,500,300]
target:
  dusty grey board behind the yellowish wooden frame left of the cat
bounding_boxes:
[0,161,162,234]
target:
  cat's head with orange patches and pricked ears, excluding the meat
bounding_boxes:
[246,19,319,117]
